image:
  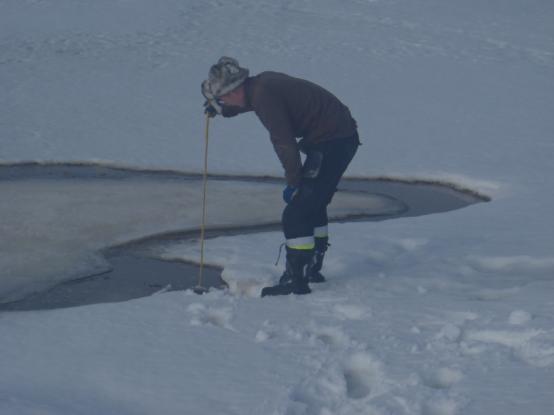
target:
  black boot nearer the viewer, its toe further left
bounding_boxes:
[262,247,314,297]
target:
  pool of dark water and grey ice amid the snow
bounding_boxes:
[0,164,486,310]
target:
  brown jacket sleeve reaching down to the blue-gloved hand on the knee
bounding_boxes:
[255,93,302,187]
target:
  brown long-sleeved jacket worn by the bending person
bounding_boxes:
[223,72,356,186]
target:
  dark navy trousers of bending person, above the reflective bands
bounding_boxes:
[282,134,360,240]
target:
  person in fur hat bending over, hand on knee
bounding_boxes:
[202,57,360,297]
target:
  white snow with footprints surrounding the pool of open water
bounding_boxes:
[0,0,554,415]
